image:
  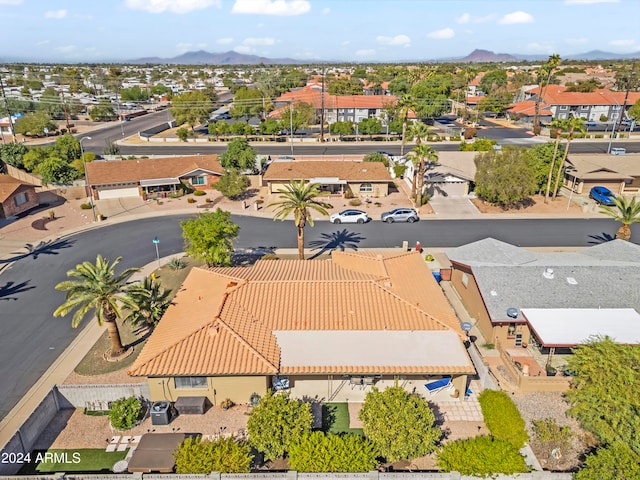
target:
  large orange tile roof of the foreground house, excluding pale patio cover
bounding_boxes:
[129,251,473,376]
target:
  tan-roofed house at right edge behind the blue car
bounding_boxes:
[564,153,640,195]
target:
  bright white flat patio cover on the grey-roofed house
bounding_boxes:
[520,308,640,347]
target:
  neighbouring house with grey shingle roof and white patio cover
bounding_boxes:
[447,238,640,348]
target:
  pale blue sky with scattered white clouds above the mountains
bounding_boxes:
[0,0,640,63]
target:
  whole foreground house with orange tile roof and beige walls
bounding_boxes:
[129,251,475,405]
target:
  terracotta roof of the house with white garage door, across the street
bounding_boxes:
[87,155,223,185]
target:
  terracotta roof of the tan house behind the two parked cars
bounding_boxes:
[263,160,391,182]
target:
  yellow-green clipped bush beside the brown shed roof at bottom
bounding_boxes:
[174,437,253,475]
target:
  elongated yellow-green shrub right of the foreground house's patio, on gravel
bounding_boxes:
[478,390,528,449]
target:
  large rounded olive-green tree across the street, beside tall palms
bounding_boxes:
[474,147,536,207]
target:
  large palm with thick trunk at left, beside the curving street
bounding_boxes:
[53,255,138,357]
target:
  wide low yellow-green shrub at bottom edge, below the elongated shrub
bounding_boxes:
[438,435,529,476]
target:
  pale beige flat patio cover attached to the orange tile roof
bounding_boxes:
[273,330,473,373]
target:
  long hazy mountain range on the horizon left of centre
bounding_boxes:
[125,50,308,65]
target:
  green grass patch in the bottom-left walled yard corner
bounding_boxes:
[19,448,127,475]
